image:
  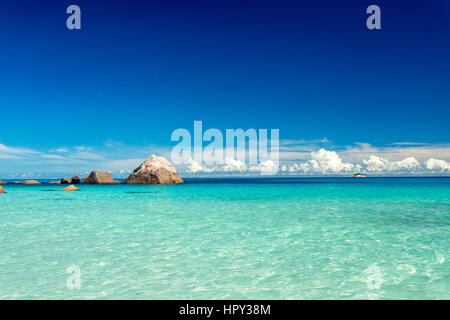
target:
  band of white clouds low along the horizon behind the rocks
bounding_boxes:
[0,139,450,179]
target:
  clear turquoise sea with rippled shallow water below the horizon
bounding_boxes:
[0,178,450,299]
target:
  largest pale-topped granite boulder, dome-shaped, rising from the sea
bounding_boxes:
[126,155,183,184]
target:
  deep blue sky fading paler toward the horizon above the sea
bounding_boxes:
[0,0,450,176]
